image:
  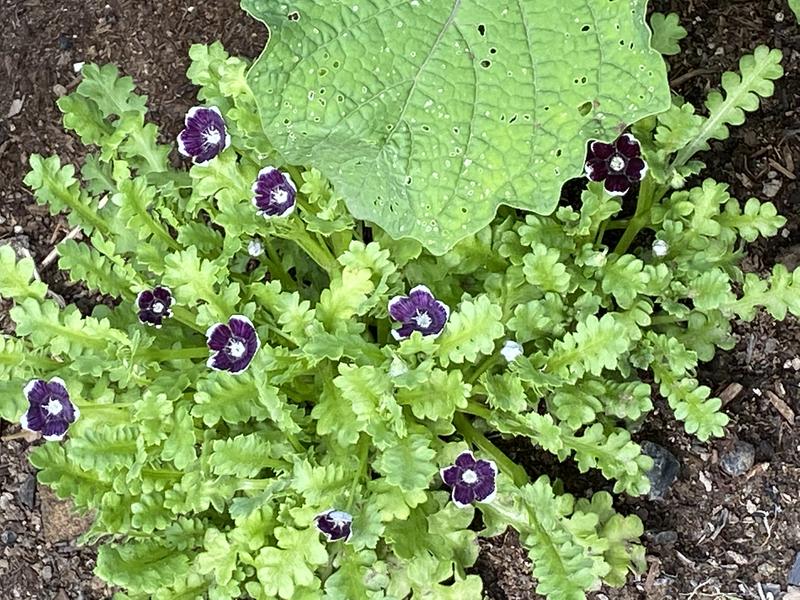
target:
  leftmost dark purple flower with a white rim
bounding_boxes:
[19,377,81,441]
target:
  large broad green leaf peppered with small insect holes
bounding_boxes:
[242,0,669,254]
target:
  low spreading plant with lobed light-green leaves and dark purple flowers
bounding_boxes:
[0,1,800,600]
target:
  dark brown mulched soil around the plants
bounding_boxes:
[0,0,800,600]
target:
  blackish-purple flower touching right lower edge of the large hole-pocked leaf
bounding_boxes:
[586,133,647,196]
